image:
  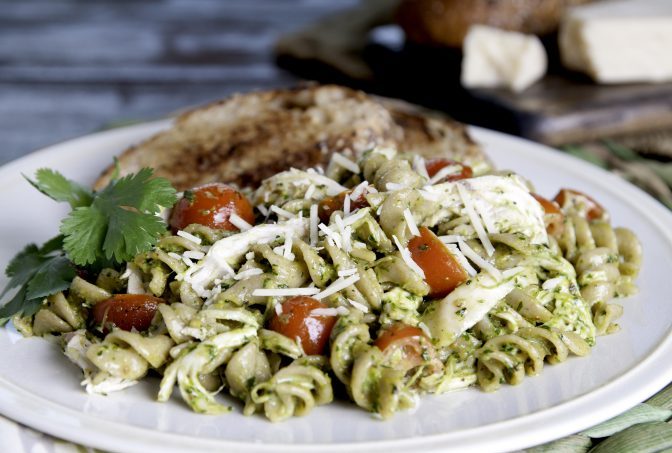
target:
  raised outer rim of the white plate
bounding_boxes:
[0,119,672,452]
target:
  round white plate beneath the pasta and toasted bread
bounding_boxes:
[0,122,672,453]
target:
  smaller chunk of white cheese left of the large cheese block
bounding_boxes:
[462,25,548,92]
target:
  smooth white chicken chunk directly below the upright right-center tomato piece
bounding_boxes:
[422,272,515,346]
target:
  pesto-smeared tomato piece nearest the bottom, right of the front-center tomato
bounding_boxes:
[373,323,434,369]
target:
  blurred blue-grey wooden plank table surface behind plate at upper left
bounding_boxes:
[0,0,357,164]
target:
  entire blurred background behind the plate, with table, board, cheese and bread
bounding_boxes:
[0,0,672,205]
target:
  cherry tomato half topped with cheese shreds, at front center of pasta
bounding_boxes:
[269,296,336,355]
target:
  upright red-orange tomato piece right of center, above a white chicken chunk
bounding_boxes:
[408,227,468,299]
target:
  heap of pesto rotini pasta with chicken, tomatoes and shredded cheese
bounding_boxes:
[9,144,642,422]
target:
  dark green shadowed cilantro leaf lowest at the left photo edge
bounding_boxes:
[0,236,76,325]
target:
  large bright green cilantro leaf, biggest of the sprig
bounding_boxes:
[61,168,176,265]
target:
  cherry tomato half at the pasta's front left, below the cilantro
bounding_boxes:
[92,294,163,331]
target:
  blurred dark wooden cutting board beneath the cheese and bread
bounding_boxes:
[277,0,672,145]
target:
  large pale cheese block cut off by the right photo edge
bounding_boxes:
[559,0,672,83]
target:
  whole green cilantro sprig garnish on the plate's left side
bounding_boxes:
[0,168,177,325]
